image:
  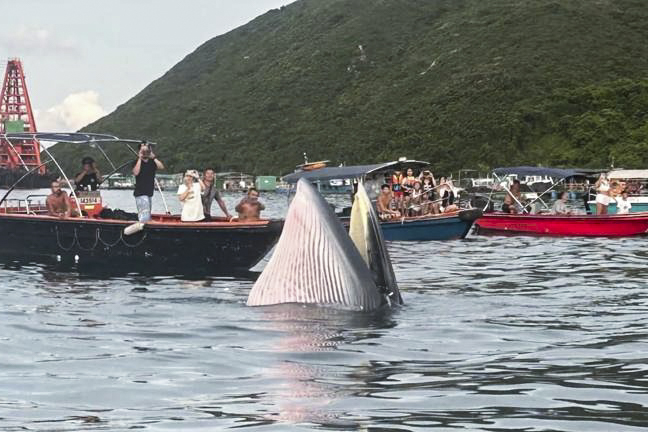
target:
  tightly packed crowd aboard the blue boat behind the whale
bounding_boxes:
[376,168,459,220]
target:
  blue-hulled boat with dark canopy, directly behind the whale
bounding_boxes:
[282,158,482,241]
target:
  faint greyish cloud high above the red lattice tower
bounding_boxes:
[0,25,80,56]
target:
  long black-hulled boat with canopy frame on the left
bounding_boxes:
[0,133,283,275]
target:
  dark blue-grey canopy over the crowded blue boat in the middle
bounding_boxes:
[282,160,430,184]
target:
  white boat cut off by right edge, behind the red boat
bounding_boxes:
[587,169,648,214]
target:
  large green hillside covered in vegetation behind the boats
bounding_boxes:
[57,0,648,174]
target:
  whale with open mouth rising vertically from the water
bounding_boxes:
[247,179,403,311]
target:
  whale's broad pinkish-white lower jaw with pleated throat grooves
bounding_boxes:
[247,180,384,310]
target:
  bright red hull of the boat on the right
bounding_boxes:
[475,212,648,237]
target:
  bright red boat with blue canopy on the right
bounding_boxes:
[475,167,648,237]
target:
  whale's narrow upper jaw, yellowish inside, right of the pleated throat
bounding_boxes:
[349,184,403,304]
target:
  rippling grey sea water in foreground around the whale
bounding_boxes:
[0,192,648,431]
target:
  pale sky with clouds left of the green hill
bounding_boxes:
[0,0,293,132]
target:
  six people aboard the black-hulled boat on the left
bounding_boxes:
[46,142,265,223]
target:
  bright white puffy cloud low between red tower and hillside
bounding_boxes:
[34,90,107,132]
